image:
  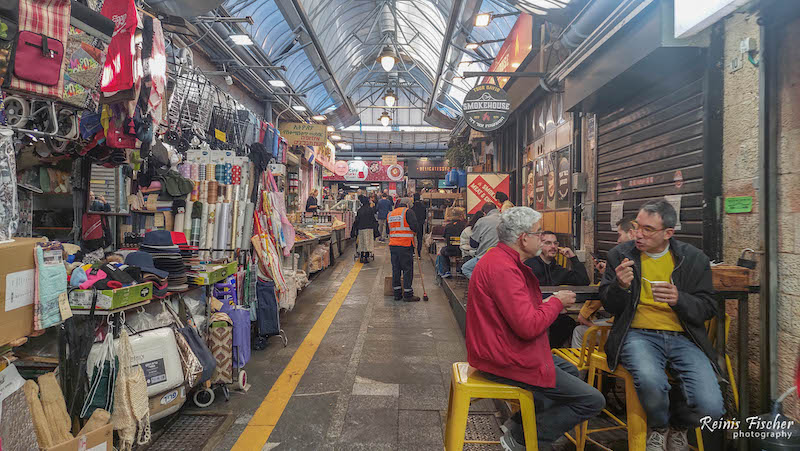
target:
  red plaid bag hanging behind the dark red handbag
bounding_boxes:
[10,0,71,99]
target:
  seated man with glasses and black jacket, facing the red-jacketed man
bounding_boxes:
[525,231,590,348]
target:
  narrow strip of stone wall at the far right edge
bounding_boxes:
[777,15,800,419]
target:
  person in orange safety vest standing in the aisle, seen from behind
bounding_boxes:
[387,197,419,302]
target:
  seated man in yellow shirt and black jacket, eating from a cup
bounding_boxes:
[600,200,725,451]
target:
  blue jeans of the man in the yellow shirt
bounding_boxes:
[619,329,725,429]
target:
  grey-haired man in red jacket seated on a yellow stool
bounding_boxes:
[466,207,605,450]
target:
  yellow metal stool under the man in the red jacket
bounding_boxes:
[444,362,539,451]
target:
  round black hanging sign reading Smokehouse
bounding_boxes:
[462,84,511,132]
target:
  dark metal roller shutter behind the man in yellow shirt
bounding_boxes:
[595,65,704,257]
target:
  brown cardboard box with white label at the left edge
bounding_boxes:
[0,238,43,345]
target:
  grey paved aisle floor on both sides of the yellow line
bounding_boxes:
[209,244,468,451]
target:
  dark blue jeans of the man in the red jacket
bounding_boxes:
[483,356,606,450]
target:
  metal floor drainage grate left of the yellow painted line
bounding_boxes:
[145,412,232,451]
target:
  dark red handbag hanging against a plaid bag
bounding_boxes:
[14,31,64,86]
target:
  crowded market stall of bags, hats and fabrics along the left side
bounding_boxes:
[0,0,332,450]
